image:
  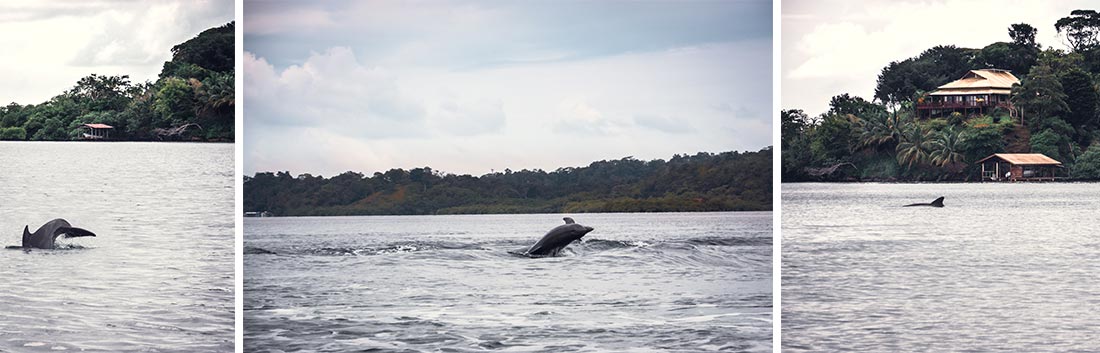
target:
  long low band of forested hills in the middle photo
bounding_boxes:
[244,147,772,216]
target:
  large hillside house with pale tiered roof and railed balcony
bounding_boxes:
[916,68,1020,118]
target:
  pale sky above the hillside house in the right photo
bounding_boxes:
[780,0,1097,117]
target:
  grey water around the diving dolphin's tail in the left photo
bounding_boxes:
[0,142,234,352]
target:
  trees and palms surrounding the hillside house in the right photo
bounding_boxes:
[781,10,1100,181]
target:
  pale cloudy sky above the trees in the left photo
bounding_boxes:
[0,0,233,104]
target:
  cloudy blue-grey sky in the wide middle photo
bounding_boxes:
[242,0,772,177]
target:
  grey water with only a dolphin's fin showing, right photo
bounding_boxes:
[782,184,1100,352]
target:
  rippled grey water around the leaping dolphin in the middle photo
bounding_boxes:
[244,212,772,352]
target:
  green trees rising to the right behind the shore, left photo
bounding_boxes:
[0,22,234,141]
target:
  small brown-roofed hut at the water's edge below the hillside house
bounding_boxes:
[978,153,1062,181]
